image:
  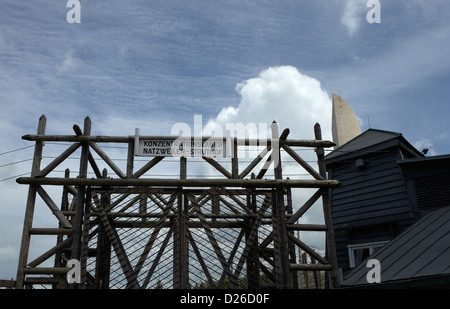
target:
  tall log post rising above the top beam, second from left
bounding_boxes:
[71,117,91,287]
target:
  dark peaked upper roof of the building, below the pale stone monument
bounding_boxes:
[325,129,423,164]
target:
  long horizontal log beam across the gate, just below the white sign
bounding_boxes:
[16,177,340,188]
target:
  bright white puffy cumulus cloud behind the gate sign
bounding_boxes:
[205,66,331,139]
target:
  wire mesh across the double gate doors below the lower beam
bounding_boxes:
[84,189,273,289]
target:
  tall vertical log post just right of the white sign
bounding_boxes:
[271,121,292,289]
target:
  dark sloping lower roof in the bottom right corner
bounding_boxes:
[343,207,450,287]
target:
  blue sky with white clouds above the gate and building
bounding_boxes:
[0,0,450,279]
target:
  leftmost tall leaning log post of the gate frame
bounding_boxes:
[16,115,47,289]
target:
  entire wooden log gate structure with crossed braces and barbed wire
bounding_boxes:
[12,115,339,289]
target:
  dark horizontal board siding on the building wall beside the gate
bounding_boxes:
[328,149,413,272]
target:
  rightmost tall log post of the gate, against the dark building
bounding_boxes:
[314,123,340,288]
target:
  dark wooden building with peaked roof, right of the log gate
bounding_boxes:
[325,129,450,275]
